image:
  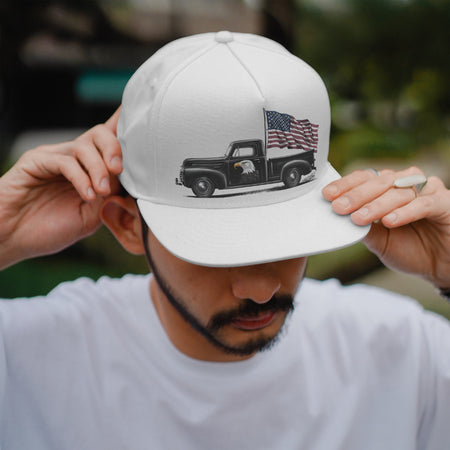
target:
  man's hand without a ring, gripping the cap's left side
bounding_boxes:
[0,110,122,268]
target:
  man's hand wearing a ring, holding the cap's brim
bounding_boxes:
[323,167,450,288]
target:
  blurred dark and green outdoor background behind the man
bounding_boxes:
[0,0,450,314]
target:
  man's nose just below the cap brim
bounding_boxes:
[231,264,281,303]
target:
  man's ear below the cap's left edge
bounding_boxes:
[100,195,144,255]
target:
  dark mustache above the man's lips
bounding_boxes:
[207,295,294,331]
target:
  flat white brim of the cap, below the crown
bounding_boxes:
[138,164,370,267]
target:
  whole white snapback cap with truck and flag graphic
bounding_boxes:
[117,31,369,267]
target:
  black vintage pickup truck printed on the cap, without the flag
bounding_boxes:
[175,139,315,197]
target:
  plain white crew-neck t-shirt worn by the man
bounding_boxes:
[0,275,450,450]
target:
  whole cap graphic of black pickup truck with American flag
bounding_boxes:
[175,110,319,197]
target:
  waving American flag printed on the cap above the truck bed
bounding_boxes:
[266,111,319,152]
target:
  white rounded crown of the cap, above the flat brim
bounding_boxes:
[118,32,330,208]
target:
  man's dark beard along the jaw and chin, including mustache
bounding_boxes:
[141,219,294,357]
